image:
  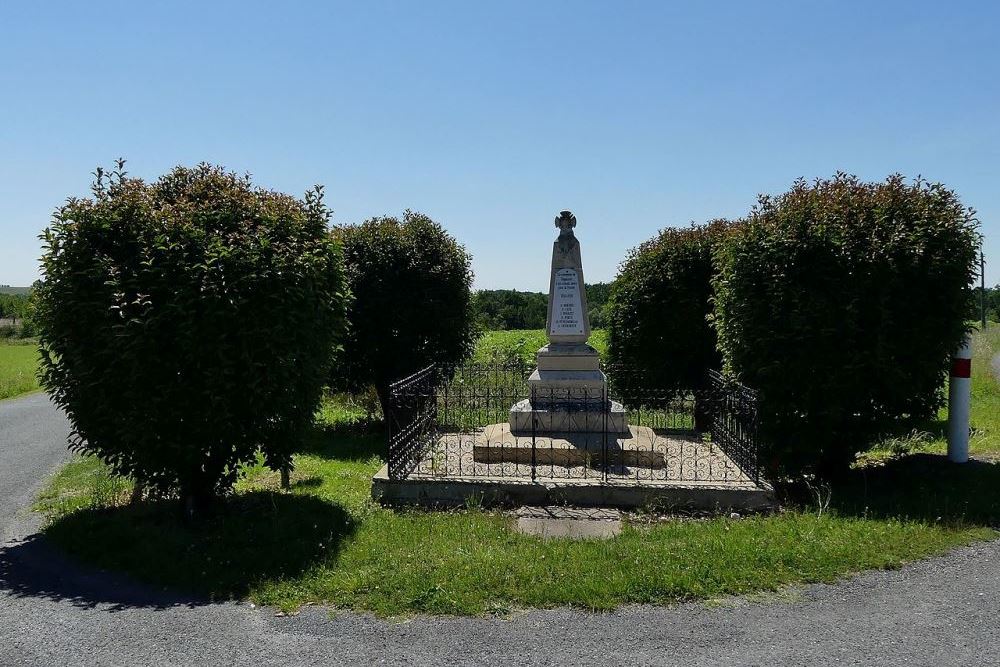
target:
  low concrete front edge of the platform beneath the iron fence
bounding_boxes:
[372,466,775,512]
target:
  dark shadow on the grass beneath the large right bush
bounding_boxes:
[816,454,1000,528]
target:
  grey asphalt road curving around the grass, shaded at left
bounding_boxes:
[0,395,1000,667]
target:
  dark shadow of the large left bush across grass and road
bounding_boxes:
[0,491,355,610]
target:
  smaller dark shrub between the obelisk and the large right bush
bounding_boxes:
[608,220,733,395]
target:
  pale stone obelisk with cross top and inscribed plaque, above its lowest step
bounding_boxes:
[510,211,628,433]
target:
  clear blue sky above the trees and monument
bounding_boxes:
[0,0,1000,290]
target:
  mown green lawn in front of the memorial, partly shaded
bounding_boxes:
[31,330,1000,616]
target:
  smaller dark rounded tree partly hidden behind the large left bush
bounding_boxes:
[333,211,476,412]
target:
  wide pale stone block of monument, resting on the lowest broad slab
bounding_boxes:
[503,400,628,436]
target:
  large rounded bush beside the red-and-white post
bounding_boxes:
[715,174,978,472]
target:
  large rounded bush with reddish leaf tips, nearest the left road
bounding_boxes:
[36,162,344,512]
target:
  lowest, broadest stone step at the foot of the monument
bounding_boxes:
[472,424,669,470]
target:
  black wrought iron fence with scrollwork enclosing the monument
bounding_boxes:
[386,363,760,484]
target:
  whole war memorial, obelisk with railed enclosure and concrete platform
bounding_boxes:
[372,211,772,508]
